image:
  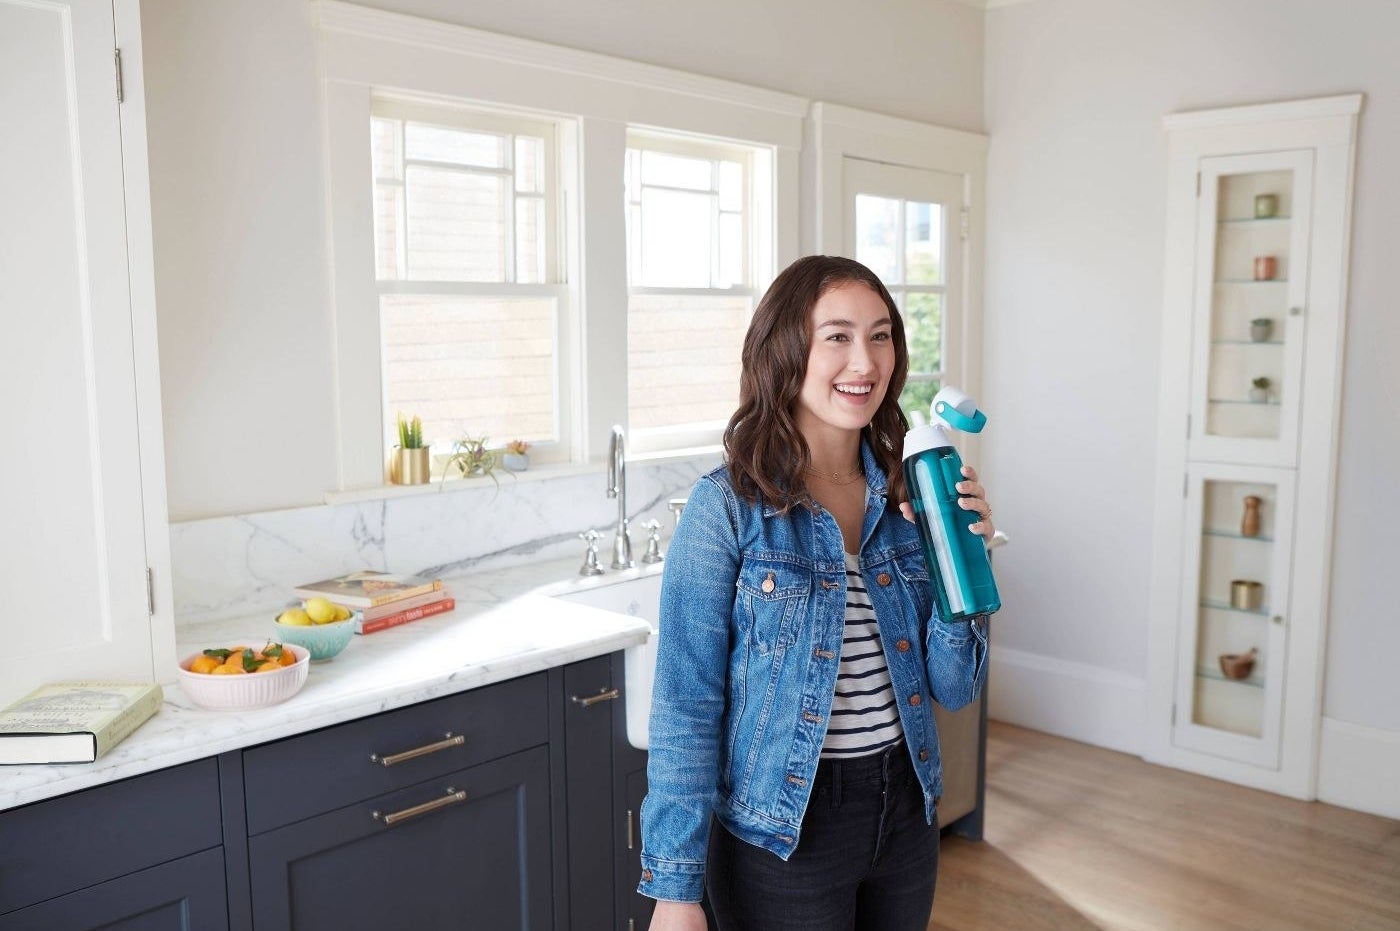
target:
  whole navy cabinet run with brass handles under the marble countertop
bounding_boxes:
[0,652,635,931]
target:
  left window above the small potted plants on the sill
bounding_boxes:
[370,99,567,459]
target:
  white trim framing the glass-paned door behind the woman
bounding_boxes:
[811,102,990,450]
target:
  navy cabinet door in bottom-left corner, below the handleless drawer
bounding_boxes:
[0,847,228,931]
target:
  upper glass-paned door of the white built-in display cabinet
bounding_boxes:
[1189,150,1313,466]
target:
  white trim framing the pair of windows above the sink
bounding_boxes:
[314,0,808,490]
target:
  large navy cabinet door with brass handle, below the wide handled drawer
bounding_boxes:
[248,748,553,931]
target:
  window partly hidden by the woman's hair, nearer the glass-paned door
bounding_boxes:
[626,130,773,452]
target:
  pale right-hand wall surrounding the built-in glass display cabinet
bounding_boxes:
[983,0,1400,809]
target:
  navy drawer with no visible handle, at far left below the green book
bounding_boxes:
[0,759,224,914]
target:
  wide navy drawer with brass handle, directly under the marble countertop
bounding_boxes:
[244,673,549,834]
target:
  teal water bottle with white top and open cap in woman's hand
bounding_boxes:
[904,388,1001,620]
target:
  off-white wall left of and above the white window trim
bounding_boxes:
[141,0,983,521]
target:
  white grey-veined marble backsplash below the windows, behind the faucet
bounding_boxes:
[171,455,720,624]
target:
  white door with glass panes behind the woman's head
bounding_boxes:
[843,158,965,413]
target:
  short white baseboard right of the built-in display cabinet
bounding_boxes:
[1317,718,1400,818]
